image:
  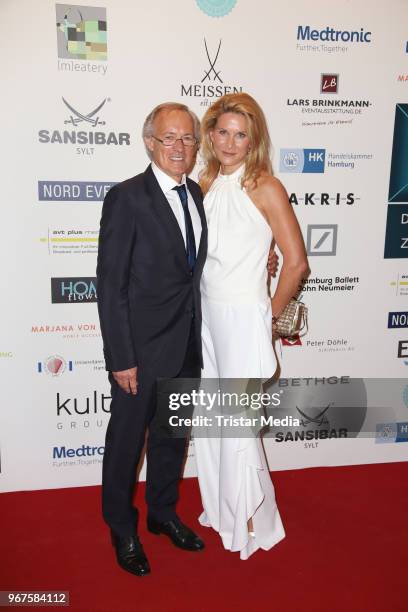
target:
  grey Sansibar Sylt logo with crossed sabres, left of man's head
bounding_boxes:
[38,98,130,155]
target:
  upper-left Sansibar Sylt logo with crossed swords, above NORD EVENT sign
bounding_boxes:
[38,97,130,155]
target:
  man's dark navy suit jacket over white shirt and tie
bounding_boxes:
[97,166,207,378]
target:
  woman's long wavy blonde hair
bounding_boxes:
[199,93,272,194]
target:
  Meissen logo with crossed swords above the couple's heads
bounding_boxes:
[181,38,242,106]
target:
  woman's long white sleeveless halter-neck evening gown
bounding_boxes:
[193,166,285,559]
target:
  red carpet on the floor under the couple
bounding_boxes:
[0,463,408,612]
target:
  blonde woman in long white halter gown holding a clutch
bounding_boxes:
[195,93,308,559]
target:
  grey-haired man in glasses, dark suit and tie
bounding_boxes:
[97,103,207,576]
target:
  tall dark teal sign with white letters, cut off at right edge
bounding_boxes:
[384,104,408,259]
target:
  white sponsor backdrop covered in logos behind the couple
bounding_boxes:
[0,0,408,491]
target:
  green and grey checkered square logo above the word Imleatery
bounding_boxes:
[55,4,108,61]
